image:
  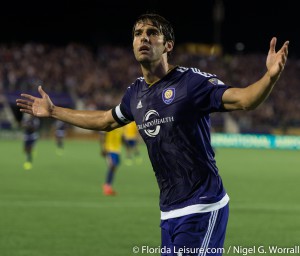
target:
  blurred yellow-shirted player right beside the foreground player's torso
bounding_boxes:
[123,122,142,165]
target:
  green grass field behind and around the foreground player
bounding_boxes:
[0,140,300,256]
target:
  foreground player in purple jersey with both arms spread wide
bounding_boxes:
[17,14,289,256]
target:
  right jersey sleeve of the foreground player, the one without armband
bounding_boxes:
[188,73,230,113]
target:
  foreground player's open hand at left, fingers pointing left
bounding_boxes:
[16,86,54,117]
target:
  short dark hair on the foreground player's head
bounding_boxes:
[132,13,175,43]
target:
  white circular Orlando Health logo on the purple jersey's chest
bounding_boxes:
[137,109,174,137]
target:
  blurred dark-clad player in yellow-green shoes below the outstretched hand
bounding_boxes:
[21,114,40,170]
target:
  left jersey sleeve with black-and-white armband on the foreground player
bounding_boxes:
[112,87,134,126]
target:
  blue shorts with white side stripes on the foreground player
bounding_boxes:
[160,204,229,256]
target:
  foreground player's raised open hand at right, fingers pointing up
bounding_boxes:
[266,37,289,80]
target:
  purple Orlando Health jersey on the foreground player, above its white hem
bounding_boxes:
[113,67,229,212]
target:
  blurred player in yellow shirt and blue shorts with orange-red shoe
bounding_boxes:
[99,128,123,196]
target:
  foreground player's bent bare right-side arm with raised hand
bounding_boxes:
[222,37,289,110]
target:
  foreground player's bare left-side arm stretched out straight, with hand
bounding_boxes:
[16,86,120,131]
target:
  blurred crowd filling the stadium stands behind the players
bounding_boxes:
[0,43,300,134]
